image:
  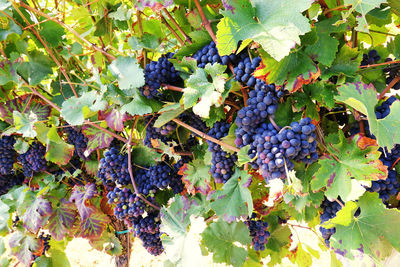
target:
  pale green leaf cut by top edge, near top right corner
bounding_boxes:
[343,0,386,32]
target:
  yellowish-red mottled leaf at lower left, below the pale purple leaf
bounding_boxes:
[79,209,110,239]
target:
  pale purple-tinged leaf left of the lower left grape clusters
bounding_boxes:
[69,183,97,220]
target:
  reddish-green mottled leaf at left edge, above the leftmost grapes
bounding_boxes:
[0,95,51,124]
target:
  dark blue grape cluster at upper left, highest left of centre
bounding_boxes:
[141,52,180,98]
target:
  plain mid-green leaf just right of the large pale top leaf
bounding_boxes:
[305,18,346,67]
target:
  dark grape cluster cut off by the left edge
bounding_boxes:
[0,136,17,175]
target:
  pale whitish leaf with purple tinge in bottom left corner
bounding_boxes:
[8,231,40,266]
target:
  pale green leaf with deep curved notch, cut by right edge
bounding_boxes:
[335,82,400,149]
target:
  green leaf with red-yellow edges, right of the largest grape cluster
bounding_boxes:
[311,132,387,201]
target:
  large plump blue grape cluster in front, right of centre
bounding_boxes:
[249,118,318,181]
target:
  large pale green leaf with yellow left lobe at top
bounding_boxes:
[217,0,311,61]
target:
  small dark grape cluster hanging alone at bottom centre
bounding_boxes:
[244,213,271,251]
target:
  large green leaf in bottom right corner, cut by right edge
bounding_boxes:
[328,192,400,257]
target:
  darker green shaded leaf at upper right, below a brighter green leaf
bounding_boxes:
[321,45,362,79]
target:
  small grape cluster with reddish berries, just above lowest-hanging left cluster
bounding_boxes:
[107,187,146,220]
